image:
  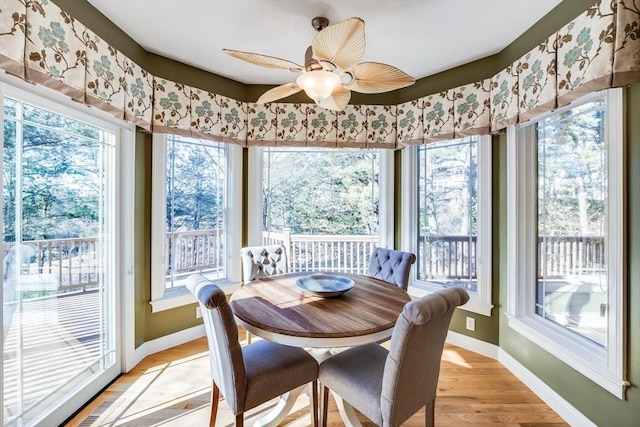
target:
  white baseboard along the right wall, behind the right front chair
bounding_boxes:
[447,331,595,427]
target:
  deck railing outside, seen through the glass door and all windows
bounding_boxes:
[3,229,606,290]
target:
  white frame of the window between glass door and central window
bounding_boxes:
[151,134,242,313]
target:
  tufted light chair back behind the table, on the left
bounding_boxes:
[240,245,288,283]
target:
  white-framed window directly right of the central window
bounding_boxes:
[403,136,491,315]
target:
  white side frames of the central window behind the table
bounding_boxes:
[247,147,394,248]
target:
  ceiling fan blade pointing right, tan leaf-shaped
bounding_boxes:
[347,62,416,93]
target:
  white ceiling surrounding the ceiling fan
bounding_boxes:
[88,0,561,84]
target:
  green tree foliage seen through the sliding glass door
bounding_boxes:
[3,100,108,242]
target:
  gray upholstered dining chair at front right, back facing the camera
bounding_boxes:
[319,288,469,427]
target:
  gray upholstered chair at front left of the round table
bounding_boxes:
[187,274,318,426]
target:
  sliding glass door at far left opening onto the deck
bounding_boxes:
[1,86,120,426]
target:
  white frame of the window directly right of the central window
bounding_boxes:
[402,135,493,316]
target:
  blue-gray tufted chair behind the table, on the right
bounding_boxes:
[367,248,416,291]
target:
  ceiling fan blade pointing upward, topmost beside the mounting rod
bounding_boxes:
[311,18,365,70]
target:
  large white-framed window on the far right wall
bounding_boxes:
[507,90,625,397]
